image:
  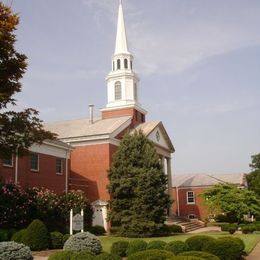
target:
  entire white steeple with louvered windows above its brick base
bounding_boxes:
[104,0,146,114]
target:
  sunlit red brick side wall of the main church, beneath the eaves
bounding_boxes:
[69,144,117,202]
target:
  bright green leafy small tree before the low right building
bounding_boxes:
[203,184,260,220]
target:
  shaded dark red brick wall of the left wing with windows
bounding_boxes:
[0,154,66,194]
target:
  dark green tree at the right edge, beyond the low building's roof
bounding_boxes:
[247,153,260,197]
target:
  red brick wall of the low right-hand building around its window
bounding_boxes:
[172,187,208,220]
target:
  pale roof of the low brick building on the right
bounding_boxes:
[172,173,247,187]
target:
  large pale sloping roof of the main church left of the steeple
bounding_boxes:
[44,116,131,139]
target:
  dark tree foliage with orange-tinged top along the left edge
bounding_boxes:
[0,3,55,157]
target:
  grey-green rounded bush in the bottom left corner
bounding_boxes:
[0,241,33,260]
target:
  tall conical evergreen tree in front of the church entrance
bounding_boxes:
[108,131,171,237]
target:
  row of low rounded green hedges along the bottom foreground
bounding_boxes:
[111,235,245,260]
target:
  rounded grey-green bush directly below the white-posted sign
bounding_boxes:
[63,232,102,254]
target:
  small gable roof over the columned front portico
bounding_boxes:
[134,121,175,153]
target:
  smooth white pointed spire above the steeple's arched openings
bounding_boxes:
[115,0,129,54]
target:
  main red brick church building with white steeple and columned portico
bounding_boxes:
[45,1,174,232]
